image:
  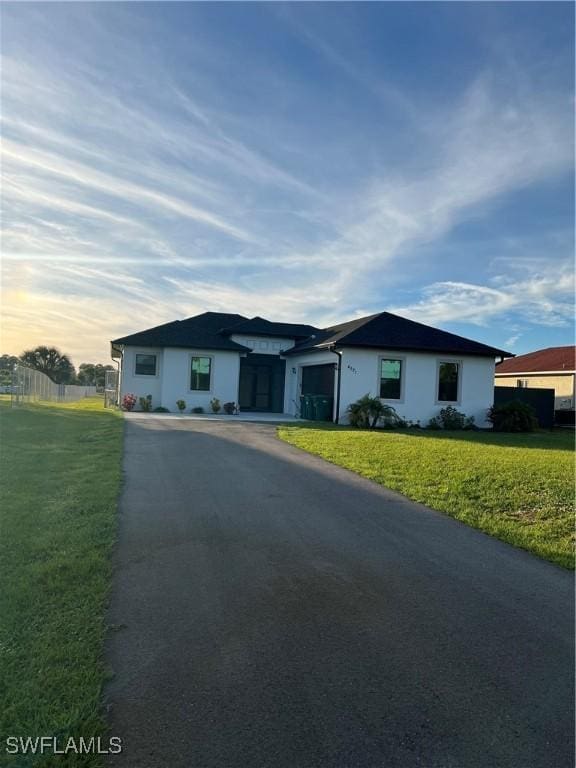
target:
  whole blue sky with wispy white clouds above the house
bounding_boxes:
[1,2,574,364]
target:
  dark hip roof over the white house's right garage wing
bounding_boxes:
[285,312,510,357]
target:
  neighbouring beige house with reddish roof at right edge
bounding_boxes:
[495,346,576,411]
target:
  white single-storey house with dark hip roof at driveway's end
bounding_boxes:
[112,312,510,426]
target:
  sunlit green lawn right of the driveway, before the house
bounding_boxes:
[278,425,574,568]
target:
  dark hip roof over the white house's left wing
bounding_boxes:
[112,312,247,352]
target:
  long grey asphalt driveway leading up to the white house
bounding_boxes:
[106,416,574,768]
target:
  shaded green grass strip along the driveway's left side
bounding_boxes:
[0,398,122,768]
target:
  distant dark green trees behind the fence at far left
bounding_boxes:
[0,346,116,387]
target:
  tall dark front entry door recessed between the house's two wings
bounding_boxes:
[239,355,286,413]
